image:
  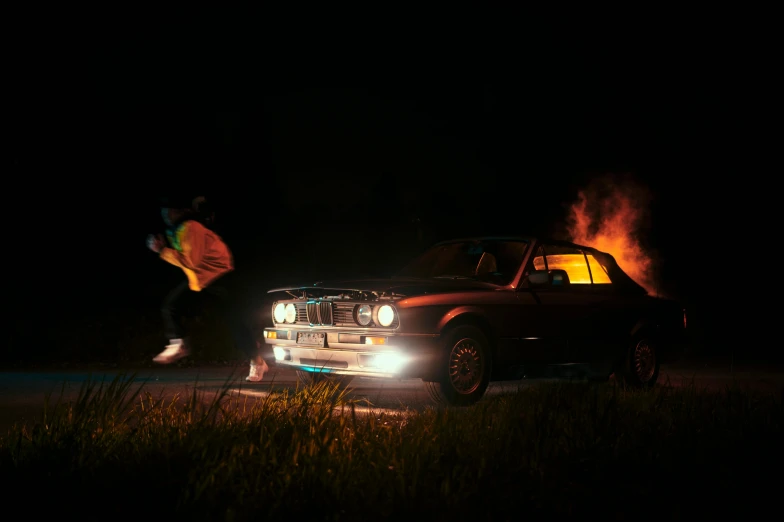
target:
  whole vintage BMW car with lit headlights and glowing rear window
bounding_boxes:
[264,237,686,406]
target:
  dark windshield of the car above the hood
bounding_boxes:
[396,239,528,285]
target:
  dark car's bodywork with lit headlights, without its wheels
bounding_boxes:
[265,236,685,380]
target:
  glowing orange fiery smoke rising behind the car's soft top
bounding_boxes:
[567,179,657,295]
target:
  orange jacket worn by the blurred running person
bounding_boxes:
[160,221,234,292]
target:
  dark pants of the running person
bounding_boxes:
[161,274,260,359]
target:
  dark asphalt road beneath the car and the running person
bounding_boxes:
[0,362,784,434]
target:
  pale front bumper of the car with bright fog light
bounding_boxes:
[264,326,439,379]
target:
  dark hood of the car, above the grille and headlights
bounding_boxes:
[269,277,499,297]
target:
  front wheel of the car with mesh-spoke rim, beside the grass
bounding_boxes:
[425,325,492,406]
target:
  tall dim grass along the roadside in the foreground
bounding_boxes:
[0,376,784,520]
